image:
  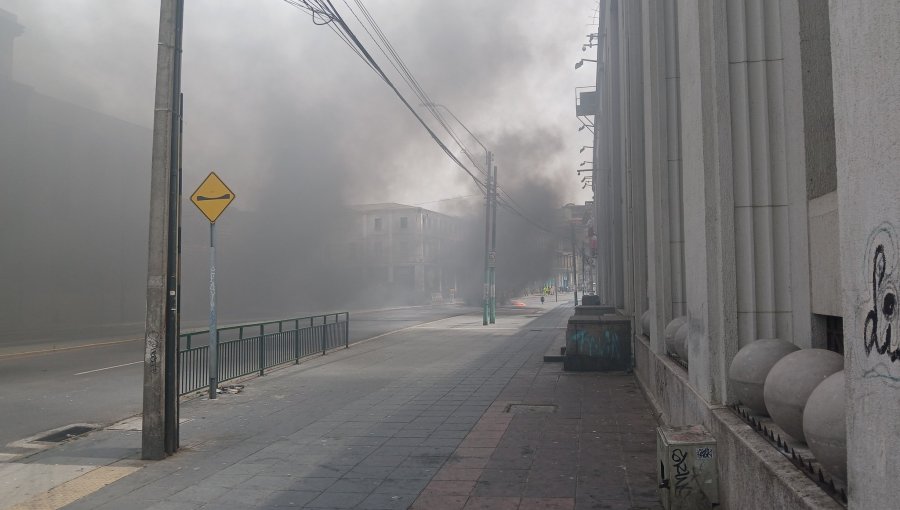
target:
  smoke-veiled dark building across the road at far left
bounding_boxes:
[0,9,151,338]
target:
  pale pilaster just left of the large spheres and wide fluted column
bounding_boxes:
[678,0,737,404]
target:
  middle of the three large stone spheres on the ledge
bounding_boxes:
[763,349,844,443]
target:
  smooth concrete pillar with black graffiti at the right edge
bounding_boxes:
[830,0,900,509]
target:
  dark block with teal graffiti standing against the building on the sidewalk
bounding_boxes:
[563,306,632,372]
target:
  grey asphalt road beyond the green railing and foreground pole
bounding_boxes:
[0,305,471,456]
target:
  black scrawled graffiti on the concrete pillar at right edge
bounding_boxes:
[862,223,900,362]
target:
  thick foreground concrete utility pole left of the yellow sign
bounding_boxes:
[141,0,184,460]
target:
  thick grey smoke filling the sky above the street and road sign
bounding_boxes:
[0,0,591,342]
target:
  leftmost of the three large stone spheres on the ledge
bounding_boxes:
[728,338,800,416]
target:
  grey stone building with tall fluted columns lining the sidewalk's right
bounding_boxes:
[578,0,900,509]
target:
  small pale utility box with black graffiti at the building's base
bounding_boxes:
[656,425,719,510]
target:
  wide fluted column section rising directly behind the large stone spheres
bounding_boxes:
[726,0,810,347]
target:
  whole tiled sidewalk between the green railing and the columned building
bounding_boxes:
[0,303,661,510]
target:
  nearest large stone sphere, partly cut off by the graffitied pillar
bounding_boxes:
[803,370,847,481]
